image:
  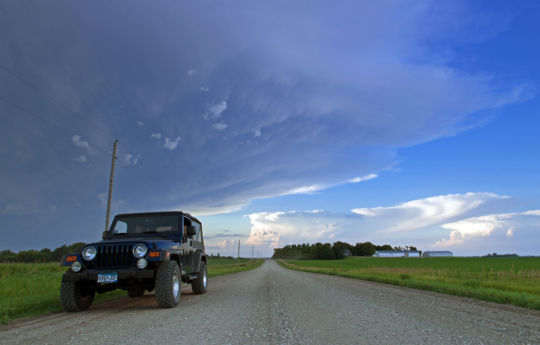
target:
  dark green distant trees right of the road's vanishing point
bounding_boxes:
[272,241,417,260]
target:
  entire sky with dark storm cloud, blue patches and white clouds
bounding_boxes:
[0,0,540,256]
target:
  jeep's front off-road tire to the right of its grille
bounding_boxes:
[156,260,182,308]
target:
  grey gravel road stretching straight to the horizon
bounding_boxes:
[0,260,540,344]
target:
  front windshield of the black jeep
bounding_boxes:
[111,215,179,236]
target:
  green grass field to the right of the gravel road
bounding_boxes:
[279,257,540,310]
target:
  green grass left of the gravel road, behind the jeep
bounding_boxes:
[0,258,263,323]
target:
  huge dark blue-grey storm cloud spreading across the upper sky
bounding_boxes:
[0,1,529,250]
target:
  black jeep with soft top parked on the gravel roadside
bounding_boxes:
[60,212,207,311]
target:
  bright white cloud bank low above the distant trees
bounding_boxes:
[247,193,524,255]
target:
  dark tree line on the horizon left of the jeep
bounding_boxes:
[0,242,85,262]
